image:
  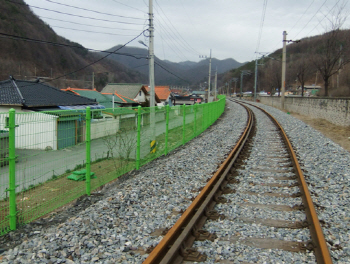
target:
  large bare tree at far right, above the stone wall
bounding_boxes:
[312,7,350,96]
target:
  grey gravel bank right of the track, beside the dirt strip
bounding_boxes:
[257,101,350,264]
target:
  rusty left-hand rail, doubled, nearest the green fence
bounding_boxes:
[143,103,253,264]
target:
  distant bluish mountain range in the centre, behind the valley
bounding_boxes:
[103,45,242,85]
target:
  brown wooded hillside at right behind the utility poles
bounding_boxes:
[223,28,350,97]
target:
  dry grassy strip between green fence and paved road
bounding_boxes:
[0,159,135,233]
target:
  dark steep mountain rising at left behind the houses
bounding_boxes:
[0,0,148,89]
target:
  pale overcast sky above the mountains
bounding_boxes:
[25,0,350,62]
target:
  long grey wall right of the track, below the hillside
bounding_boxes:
[259,96,350,126]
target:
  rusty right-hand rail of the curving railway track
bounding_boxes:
[252,105,333,264]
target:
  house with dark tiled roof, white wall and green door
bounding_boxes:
[0,78,104,150]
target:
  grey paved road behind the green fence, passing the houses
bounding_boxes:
[0,110,202,199]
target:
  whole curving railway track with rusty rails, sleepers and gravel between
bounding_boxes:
[144,99,332,263]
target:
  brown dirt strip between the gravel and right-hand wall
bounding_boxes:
[290,113,350,152]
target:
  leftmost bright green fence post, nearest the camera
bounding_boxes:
[5,108,18,230]
